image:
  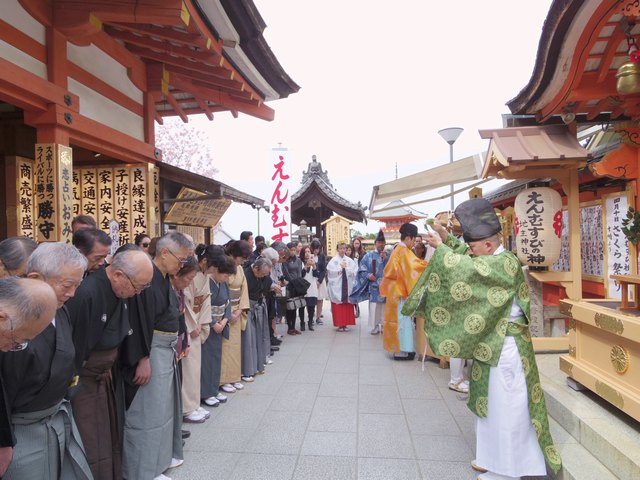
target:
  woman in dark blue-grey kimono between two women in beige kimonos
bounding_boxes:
[200,246,237,406]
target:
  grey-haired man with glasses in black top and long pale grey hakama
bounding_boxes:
[121,231,194,479]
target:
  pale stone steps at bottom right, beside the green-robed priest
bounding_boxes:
[536,354,640,480]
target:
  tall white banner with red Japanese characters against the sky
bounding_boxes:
[269,148,293,243]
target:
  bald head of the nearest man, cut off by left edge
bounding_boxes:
[0,277,58,352]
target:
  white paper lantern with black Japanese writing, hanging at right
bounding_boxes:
[514,187,562,267]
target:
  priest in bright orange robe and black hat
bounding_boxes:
[380,223,427,360]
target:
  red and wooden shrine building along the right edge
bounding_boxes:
[485,0,640,426]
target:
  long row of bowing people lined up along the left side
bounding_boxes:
[0,216,353,480]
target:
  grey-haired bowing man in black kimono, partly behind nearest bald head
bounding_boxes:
[0,246,92,480]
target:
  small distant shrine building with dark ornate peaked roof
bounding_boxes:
[291,155,366,248]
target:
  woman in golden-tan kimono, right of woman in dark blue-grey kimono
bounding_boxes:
[220,240,251,393]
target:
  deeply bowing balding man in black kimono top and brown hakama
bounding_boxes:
[66,249,153,480]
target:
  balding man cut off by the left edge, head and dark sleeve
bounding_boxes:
[0,277,58,475]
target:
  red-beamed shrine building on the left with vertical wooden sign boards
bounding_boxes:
[0,0,299,242]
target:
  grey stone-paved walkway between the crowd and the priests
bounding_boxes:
[172,308,477,480]
